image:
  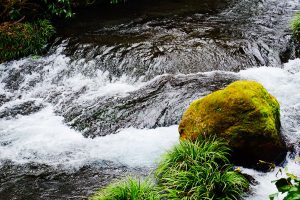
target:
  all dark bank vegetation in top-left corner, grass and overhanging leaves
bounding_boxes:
[0,0,120,63]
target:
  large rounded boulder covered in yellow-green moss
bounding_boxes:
[179,81,286,166]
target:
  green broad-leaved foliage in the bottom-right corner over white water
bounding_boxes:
[270,173,300,200]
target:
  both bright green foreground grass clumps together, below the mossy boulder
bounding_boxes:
[90,138,249,200]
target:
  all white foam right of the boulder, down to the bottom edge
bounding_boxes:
[239,59,300,200]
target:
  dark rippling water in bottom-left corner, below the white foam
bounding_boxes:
[0,161,148,200]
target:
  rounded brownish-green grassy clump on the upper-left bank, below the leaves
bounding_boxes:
[0,20,55,62]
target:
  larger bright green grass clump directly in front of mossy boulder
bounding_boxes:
[156,138,249,200]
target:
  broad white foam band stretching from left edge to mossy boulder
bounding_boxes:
[0,106,179,167]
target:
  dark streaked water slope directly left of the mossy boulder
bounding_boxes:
[63,72,238,137]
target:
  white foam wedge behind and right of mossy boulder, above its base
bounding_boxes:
[239,63,300,147]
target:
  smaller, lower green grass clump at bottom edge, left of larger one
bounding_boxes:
[90,177,160,200]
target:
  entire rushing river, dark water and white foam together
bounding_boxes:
[0,0,300,200]
